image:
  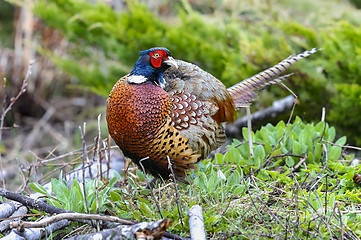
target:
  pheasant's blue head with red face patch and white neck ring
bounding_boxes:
[127,47,177,88]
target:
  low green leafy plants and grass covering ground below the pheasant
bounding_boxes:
[31,118,361,239]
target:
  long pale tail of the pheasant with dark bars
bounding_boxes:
[227,48,320,109]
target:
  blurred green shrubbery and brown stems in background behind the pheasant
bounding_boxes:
[0,0,361,171]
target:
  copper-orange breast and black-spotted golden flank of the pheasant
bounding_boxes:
[107,76,199,178]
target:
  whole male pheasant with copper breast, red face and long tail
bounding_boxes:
[106,47,317,179]
